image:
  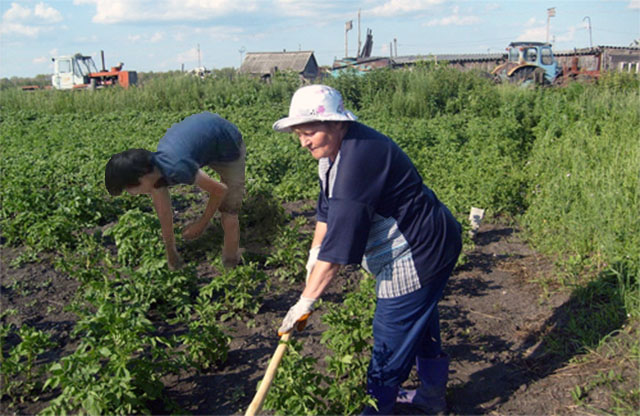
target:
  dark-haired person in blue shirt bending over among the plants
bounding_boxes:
[105,111,246,269]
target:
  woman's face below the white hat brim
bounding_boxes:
[293,122,346,160]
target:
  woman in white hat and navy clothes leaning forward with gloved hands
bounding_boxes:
[273,85,462,414]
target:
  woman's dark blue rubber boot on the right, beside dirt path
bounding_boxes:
[396,355,449,414]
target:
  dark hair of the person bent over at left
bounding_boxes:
[104,149,153,196]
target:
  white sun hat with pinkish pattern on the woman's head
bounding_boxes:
[273,84,357,132]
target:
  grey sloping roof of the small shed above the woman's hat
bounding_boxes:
[240,51,318,74]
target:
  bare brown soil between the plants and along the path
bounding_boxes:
[0,206,632,415]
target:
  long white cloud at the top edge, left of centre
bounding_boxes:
[73,0,258,24]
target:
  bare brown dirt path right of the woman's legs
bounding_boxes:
[441,225,572,415]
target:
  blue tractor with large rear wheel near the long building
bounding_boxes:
[491,42,562,85]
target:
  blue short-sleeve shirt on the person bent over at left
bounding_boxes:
[152,111,242,185]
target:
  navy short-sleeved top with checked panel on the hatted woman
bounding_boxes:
[317,122,461,298]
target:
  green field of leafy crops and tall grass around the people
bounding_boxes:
[0,67,640,414]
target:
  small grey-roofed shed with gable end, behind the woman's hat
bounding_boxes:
[240,51,318,80]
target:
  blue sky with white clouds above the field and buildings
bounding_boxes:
[0,0,640,78]
